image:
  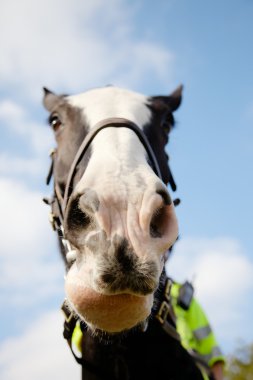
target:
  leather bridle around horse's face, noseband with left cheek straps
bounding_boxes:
[44,117,176,255]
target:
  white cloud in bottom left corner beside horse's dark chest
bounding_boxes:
[0,311,81,380]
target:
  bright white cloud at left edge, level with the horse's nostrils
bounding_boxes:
[0,178,49,258]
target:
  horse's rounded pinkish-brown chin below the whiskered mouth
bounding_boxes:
[66,281,153,334]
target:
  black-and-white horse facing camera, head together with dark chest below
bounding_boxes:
[43,86,202,380]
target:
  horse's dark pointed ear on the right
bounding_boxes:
[152,85,183,112]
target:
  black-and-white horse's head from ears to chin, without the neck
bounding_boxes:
[44,87,181,333]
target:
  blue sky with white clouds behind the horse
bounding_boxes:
[0,0,253,380]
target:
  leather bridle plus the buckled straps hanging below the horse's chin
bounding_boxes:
[43,118,180,372]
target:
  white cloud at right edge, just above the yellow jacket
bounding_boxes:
[167,238,253,348]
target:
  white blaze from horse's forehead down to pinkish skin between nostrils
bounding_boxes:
[67,87,176,256]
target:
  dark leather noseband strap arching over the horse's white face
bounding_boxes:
[62,117,162,214]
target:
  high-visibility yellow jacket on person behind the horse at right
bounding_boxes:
[171,283,225,367]
